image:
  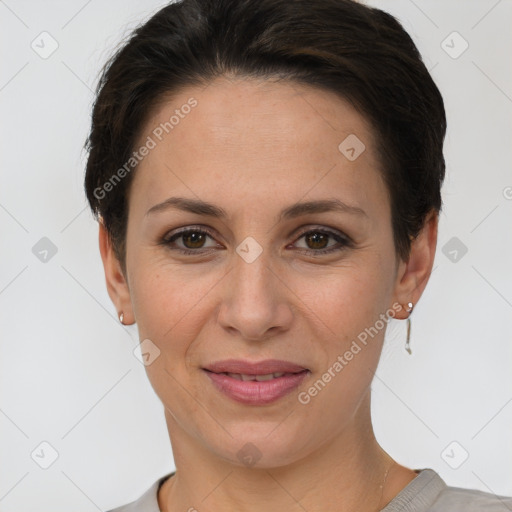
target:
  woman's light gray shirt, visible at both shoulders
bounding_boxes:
[109,469,512,512]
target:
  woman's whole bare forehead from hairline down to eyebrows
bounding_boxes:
[132,77,383,218]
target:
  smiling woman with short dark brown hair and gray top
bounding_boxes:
[85,0,512,512]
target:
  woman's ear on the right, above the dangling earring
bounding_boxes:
[394,210,439,319]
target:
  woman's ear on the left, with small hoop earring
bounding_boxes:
[99,221,135,325]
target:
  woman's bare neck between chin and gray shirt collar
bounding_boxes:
[158,393,416,512]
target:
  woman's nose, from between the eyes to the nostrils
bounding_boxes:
[218,250,293,341]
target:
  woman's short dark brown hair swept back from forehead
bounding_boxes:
[85,0,446,268]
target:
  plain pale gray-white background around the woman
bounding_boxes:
[0,0,512,512]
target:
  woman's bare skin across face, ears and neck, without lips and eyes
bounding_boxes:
[99,77,438,512]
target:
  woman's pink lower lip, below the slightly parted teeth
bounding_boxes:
[204,370,309,405]
